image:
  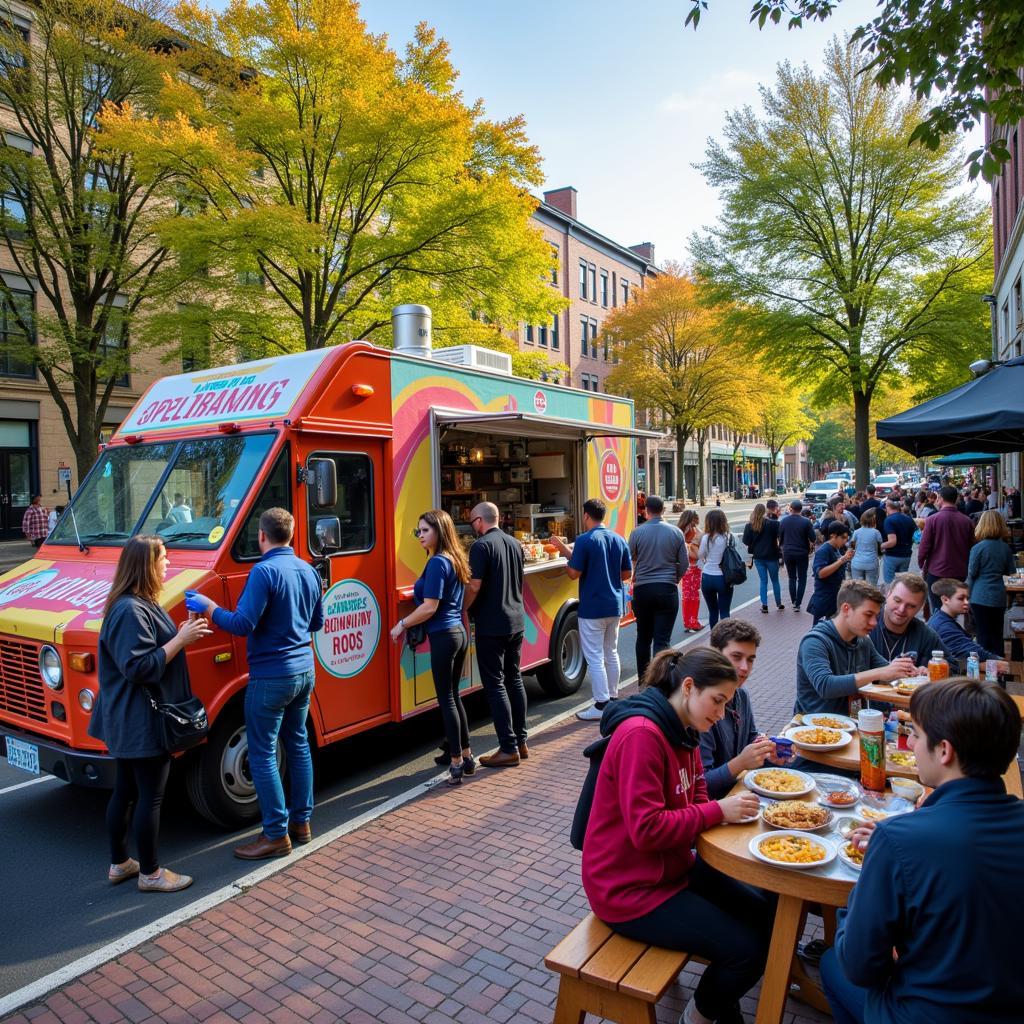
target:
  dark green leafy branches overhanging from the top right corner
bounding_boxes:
[686,0,1024,180]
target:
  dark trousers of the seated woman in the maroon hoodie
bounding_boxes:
[609,860,776,1020]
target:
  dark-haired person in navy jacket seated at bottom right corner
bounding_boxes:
[821,679,1024,1024]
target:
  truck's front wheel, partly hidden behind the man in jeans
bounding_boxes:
[185,703,287,828]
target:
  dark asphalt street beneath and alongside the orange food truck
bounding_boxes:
[0,502,757,995]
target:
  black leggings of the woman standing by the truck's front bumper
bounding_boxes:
[106,754,171,874]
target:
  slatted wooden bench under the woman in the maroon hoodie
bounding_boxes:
[544,913,690,1024]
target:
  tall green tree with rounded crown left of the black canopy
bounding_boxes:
[693,41,991,486]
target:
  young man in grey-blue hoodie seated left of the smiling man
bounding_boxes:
[793,580,918,715]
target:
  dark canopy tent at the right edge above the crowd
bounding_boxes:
[874,356,1024,457]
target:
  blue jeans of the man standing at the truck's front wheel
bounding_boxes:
[246,669,315,839]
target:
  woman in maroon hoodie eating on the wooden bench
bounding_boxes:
[583,647,775,1024]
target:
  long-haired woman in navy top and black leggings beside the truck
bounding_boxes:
[391,509,476,785]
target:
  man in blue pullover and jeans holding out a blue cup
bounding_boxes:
[195,508,324,860]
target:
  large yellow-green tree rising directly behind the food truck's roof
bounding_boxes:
[110,0,564,360]
